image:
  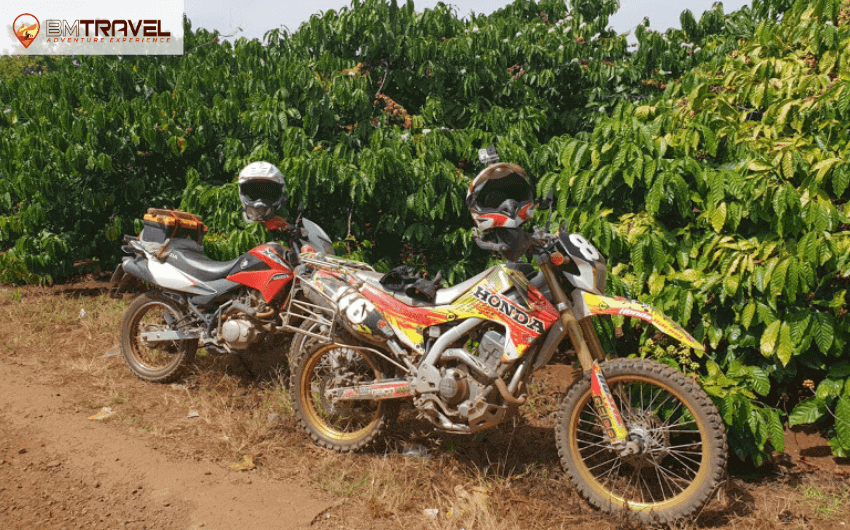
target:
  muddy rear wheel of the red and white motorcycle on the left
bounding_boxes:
[121,292,198,383]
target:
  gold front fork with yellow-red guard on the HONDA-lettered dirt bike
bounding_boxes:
[538,260,639,455]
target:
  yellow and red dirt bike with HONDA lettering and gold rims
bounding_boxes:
[290,200,727,522]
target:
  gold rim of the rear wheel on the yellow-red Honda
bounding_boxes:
[299,344,383,442]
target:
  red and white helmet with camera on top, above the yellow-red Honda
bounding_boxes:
[466,162,534,235]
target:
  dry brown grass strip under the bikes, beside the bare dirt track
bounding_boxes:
[0,285,850,530]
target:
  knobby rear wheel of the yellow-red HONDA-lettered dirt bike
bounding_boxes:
[289,338,398,453]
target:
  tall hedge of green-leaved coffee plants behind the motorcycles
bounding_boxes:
[0,0,850,464]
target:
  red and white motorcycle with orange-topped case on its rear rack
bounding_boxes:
[112,209,333,383]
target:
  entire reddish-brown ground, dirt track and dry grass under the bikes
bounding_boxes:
[0,283,850,530]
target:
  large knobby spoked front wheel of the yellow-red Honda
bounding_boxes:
[555,359,727,523]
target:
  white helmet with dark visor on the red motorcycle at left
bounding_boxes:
[239,162,286,223]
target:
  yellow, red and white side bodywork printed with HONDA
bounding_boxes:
[361,265,559,361]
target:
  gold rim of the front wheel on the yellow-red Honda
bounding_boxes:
[569,375,711,511]
